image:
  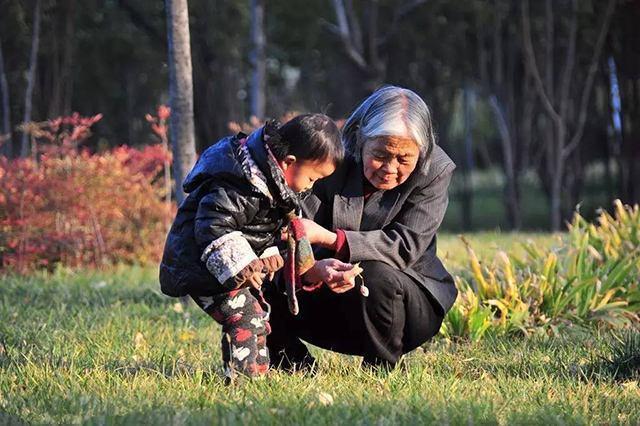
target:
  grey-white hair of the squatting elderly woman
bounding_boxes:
[342,86,436,162]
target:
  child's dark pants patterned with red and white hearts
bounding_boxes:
[191,287,271,378]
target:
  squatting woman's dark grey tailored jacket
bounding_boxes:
[302,146,458,313]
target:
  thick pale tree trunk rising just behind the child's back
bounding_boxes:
[165,0,196,204]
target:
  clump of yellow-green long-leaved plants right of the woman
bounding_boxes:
[441,200,640,340]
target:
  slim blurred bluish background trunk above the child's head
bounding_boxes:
[250,0,266,118]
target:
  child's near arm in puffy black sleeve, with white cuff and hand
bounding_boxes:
[194,185,264,288]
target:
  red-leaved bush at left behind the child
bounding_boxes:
[0,115,175,272]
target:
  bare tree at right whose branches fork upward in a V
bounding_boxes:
[521,0,616,230]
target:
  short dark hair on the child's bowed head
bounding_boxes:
[264,114,344,166]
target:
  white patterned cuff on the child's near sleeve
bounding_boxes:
[200,231,258,284]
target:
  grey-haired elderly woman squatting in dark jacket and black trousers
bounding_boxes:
[268,86,457,369]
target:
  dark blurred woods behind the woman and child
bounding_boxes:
[0,0,640,233]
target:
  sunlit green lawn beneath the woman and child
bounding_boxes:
[0,255,640,425]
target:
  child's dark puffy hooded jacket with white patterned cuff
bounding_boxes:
[160,127,299,297]
